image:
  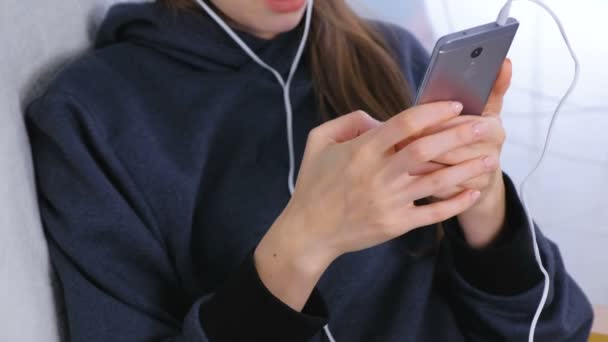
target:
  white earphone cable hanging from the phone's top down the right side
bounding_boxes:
[496,0,580,342]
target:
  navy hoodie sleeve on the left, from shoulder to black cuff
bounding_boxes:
[26,94,327,342]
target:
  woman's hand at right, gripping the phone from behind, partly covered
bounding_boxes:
[408,59,512,248]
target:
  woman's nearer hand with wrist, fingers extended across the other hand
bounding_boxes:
[254,102,495,310]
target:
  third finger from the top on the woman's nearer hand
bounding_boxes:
[404,156,498,201]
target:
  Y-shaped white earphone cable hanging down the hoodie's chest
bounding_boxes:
[190,0,336,342]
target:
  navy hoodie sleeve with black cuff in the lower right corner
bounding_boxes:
[439,175,593,342]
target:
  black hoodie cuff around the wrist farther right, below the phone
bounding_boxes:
[445,174,542,296]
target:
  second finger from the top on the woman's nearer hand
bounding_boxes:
[385,121,487,179]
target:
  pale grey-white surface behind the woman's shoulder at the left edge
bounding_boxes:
[0,0,147,342]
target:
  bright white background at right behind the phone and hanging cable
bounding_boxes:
[351,0,608,304]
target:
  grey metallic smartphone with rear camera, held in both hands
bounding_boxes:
[416,18,519,115]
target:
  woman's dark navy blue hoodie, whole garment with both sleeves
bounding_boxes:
[27,4,592,342]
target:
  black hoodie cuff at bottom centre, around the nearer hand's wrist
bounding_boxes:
[201,252,328,342]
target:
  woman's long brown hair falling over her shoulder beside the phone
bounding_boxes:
[157,0,443,251]
